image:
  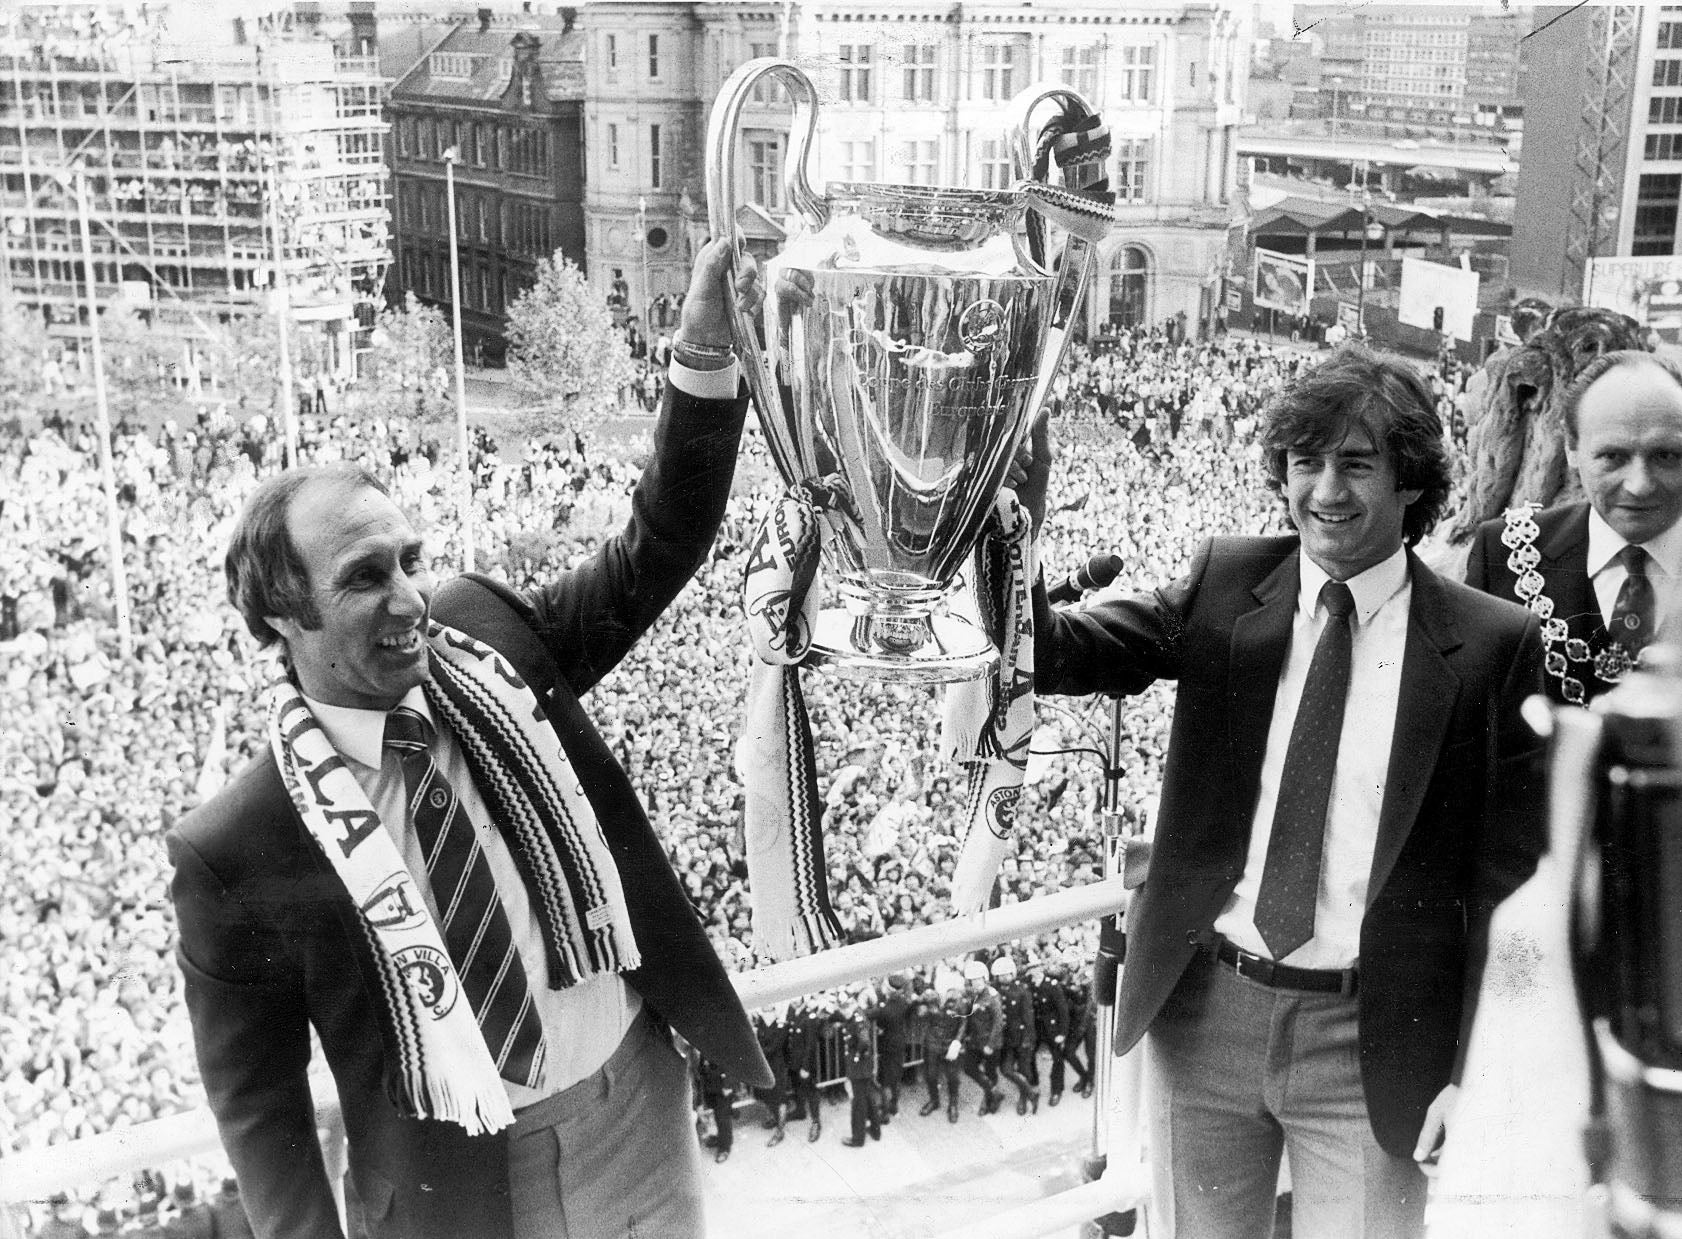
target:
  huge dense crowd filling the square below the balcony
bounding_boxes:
[0,319,1299,1219]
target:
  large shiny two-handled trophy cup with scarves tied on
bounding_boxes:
[706,59,1115,957]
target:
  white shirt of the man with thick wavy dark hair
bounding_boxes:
[1214,548,1413,968]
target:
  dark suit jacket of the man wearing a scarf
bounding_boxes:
[168,385,770,1239]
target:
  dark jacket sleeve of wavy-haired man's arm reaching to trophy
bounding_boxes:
[1034,538,1213,696]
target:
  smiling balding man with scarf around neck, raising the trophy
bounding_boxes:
[168,245,770,1239]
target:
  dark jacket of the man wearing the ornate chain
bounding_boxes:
[1467,501,1611,704]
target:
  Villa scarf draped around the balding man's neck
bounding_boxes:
[269,622,641,1135]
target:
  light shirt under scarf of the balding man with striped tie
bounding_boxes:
[304,688,643,1110]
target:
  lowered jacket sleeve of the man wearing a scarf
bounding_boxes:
[167,832,341,1239]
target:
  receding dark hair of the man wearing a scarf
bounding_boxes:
[222,464,389,646]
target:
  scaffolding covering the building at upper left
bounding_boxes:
[0,3,390,375]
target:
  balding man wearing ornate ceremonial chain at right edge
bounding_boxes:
[1467,351,1682,704]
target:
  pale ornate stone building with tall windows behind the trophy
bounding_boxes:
[579,0,1248,341]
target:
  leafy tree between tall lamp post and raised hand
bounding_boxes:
[508,250,636,434]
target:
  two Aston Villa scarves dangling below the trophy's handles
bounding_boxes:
[735,486,1034,960]
